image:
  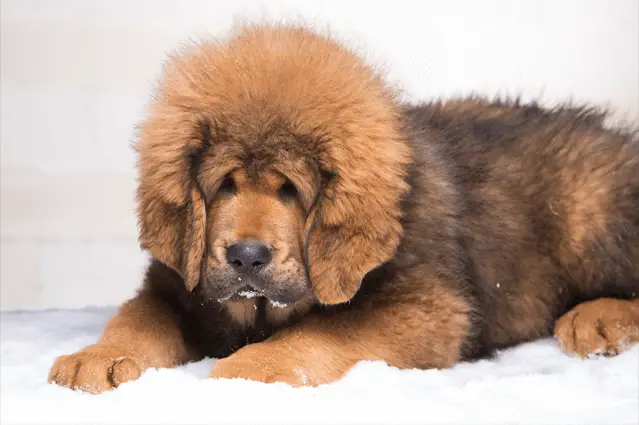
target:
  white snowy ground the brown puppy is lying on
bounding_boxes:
[0,308,639,425]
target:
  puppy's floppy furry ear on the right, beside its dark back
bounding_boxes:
[305,127,411,304]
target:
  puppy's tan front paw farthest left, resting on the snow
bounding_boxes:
[49,344,143,394]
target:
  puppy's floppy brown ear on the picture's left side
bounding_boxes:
[135,108,206,291]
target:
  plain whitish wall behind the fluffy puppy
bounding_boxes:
[0,0,639,308]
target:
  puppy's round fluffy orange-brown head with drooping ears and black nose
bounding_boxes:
[136,26,411,304]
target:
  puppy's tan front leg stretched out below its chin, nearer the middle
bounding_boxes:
[211,276,470,386]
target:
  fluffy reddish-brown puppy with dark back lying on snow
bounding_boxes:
[50,25,639,392]
